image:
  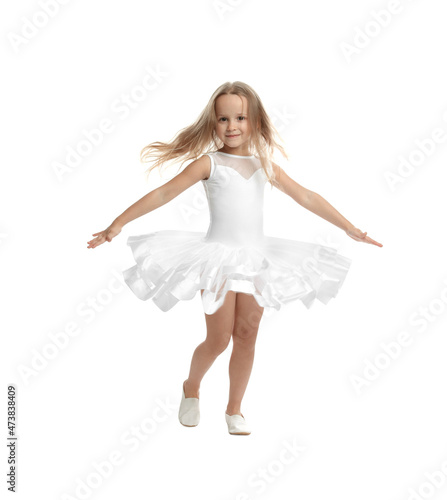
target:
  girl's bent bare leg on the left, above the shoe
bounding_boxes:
[183,290,236,398]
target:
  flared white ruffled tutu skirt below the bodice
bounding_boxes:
[123,230,351,314]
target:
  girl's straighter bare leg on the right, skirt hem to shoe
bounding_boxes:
[226,292,264,415]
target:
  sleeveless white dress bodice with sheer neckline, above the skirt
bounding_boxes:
[202,151,267,246]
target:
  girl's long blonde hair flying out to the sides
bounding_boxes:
[140,81,288,188]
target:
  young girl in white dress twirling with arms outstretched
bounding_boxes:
[87,81,383,434]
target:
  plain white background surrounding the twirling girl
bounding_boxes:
[0,0,447,500]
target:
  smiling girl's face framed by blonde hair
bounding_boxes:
[215,94,251,152]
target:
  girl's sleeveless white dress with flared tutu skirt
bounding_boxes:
[123,151,351,314]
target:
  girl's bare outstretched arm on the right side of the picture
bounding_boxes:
[272,162,383,247]
